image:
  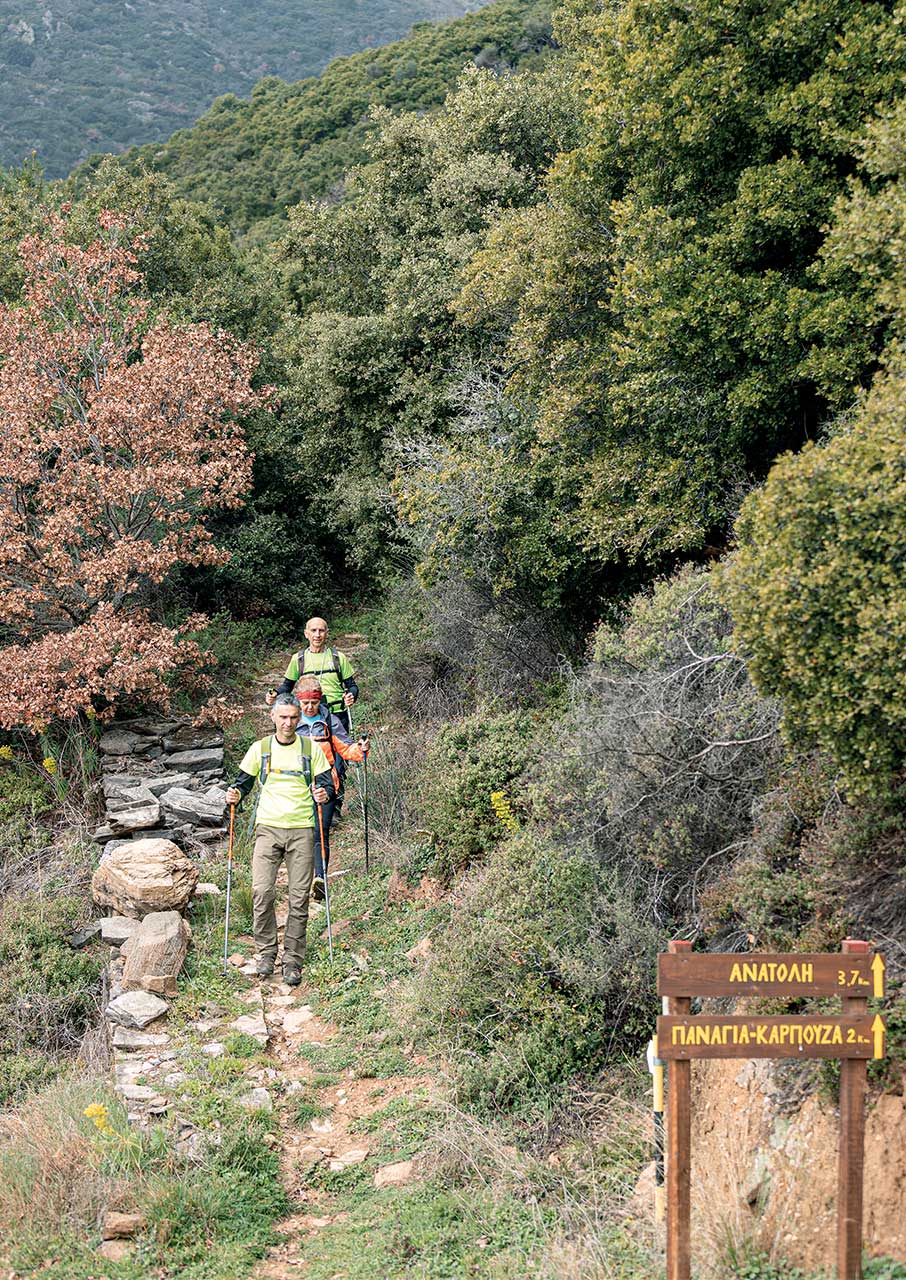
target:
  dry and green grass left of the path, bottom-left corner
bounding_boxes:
[0,1080,288,1280]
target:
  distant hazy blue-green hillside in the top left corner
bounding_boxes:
[0,0,475,178]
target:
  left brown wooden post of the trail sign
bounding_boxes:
[667,942,692,1280]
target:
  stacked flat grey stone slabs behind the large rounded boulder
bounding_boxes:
[93,719,227,856]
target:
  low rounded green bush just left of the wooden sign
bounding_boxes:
[406,833,663,1112]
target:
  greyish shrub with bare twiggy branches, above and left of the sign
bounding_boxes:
[565,568,779,923]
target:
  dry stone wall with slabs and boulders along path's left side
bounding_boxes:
[92,719,227,1123]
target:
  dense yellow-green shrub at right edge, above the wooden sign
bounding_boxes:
[723,347,906,796]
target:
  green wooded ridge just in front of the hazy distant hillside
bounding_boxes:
[83,0,552,232]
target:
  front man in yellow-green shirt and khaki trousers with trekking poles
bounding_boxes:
[227,694,334,987]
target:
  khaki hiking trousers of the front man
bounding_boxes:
[252,827,315,965]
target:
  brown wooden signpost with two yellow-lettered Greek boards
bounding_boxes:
[656,940,886,1280]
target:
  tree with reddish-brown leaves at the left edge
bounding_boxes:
[0,206,264,728]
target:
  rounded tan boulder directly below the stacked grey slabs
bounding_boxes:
[91,840,198,919]
